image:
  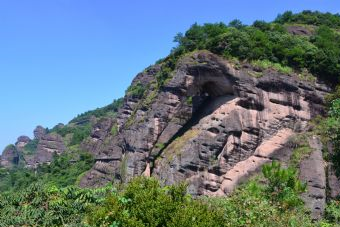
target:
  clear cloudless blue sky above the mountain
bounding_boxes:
[0,0,340,153]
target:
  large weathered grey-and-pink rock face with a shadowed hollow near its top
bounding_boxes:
[81,52,329,195]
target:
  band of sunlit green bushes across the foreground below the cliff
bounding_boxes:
[0,168,317,227]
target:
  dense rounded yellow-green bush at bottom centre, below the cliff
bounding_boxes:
[87,177,223,227]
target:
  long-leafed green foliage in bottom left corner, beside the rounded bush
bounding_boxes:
[0,183,114,227]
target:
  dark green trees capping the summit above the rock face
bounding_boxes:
[173,12,340,82]
